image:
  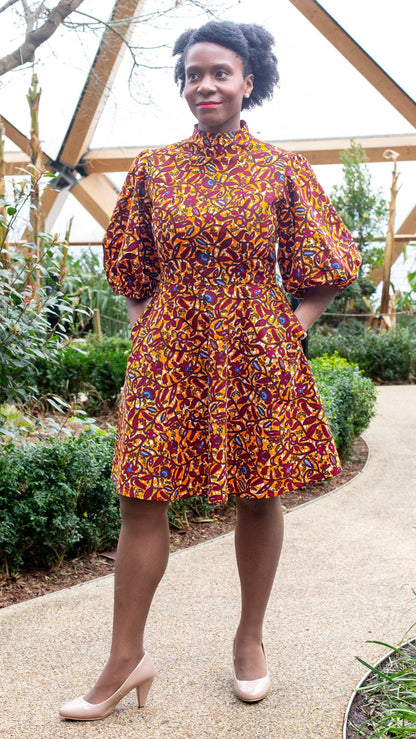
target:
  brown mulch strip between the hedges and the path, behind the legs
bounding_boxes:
[0,439,368,608]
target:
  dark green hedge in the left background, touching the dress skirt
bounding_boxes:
[37,336,131,413]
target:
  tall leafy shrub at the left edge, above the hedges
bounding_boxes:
[0,173,88,422]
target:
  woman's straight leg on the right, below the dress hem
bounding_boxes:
[234,497,283,680]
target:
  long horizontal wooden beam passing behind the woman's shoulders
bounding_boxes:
[82,134,416,173]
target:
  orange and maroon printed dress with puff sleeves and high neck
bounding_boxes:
[104,124,360,504]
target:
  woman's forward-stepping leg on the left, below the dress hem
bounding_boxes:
[85,497,169,703]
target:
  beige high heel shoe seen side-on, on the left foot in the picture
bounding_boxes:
[59,652,155,721]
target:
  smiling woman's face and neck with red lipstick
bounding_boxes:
[183,41,253,133]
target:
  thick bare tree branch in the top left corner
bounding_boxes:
[0,0,84,76]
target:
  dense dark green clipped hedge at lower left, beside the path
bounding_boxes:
[0,432,119,571]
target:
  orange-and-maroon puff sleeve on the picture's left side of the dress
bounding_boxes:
[103,152,159,300]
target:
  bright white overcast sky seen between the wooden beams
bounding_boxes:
[0,0,416,239]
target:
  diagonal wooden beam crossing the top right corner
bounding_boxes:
[290,0,416,127]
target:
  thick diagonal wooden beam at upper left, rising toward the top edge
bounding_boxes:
[58,0,144,167]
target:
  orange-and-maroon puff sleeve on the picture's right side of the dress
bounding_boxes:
[277,154,361,298]
